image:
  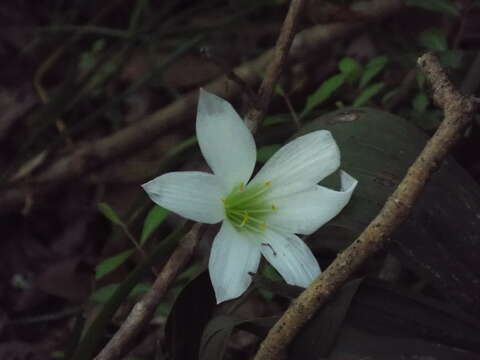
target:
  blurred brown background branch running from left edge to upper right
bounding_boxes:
[0,0,402,213]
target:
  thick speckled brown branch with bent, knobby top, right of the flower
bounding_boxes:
[251,54,474,360]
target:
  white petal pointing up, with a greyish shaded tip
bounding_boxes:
[197,89,257,188]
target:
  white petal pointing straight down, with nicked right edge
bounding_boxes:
[208,221,260,304]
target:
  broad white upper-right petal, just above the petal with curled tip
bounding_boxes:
[251,130,340,196]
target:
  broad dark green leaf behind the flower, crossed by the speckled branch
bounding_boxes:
[298,108,480,312]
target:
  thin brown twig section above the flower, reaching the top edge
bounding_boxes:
[245,0,305,132]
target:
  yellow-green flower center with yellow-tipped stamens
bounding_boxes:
[222,181,277,232]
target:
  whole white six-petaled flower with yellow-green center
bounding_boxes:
[143,90,357,303]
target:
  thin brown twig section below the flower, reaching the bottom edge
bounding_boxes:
[95,224,201,360]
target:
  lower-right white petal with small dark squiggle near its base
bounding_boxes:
[260,228,320,287]
